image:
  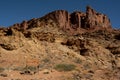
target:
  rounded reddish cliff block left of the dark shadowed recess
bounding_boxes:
[45,10,70,29]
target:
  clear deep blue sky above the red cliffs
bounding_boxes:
[0,0,120,28]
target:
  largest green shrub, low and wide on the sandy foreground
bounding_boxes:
[55,64,76,71]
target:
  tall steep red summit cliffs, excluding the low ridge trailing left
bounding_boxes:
[39,6,111,33]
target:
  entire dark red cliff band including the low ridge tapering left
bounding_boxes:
[12,6,111,35]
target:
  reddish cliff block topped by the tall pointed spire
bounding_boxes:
[84,6,111,29]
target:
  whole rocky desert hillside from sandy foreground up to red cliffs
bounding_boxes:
[0,6,120,80]
